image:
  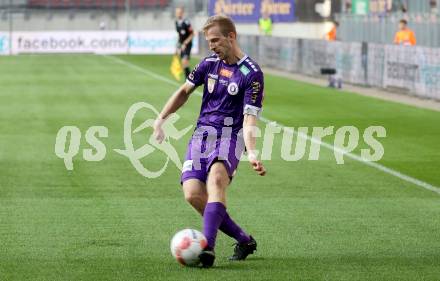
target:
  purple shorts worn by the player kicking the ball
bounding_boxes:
[180,135,244,183]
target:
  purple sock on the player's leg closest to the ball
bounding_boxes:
[203,202,226,249]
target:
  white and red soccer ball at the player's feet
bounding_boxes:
[171,229,208,266]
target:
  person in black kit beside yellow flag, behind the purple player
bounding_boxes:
[175,7,194,77]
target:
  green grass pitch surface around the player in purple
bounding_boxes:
[0,55,440,281]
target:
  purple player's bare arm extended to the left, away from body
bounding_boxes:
[154,82,196,143]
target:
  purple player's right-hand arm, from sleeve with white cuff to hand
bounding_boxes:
[243,71,266,176]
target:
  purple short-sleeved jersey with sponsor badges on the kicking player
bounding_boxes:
[187,54,264,135]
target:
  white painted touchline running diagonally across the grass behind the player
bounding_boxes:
[103,55,440,194]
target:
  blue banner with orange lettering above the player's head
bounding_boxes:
[208,0,295,23]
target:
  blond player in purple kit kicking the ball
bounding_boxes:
[154,15,266,267]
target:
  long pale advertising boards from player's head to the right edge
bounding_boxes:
[199,32,440,100]
